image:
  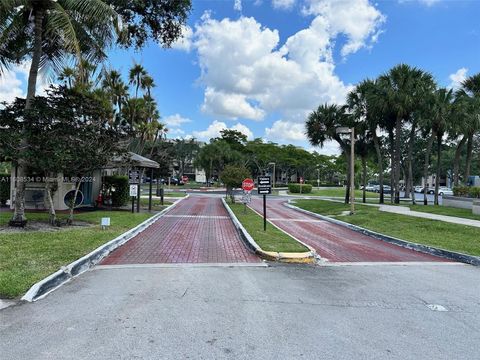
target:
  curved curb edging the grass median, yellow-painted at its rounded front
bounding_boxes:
[222,197,316,263]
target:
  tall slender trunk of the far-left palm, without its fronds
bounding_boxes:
[10,7,45,226]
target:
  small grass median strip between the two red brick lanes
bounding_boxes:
[229,203,309,252]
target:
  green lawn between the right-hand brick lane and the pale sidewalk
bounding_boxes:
[295,200,480,256]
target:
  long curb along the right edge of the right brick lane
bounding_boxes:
[284,200,480,266]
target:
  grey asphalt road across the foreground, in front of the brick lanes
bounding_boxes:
[0,264,480,360]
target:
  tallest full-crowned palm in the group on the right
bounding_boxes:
[378,64,434,204]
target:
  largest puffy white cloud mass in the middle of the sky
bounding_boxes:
[182,0,385,121]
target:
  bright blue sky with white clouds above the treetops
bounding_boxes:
[0,0,480,154]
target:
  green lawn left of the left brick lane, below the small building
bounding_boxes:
[0,211,152,298]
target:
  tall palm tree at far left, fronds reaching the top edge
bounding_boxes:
[0,0,118,225]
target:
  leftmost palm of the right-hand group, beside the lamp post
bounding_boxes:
[306,104,354,204]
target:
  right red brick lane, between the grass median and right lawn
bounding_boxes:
[251,199,447,262]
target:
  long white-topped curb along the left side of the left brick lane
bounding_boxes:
[22,196,188,302]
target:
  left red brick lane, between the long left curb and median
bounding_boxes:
[101,196,260,265]
